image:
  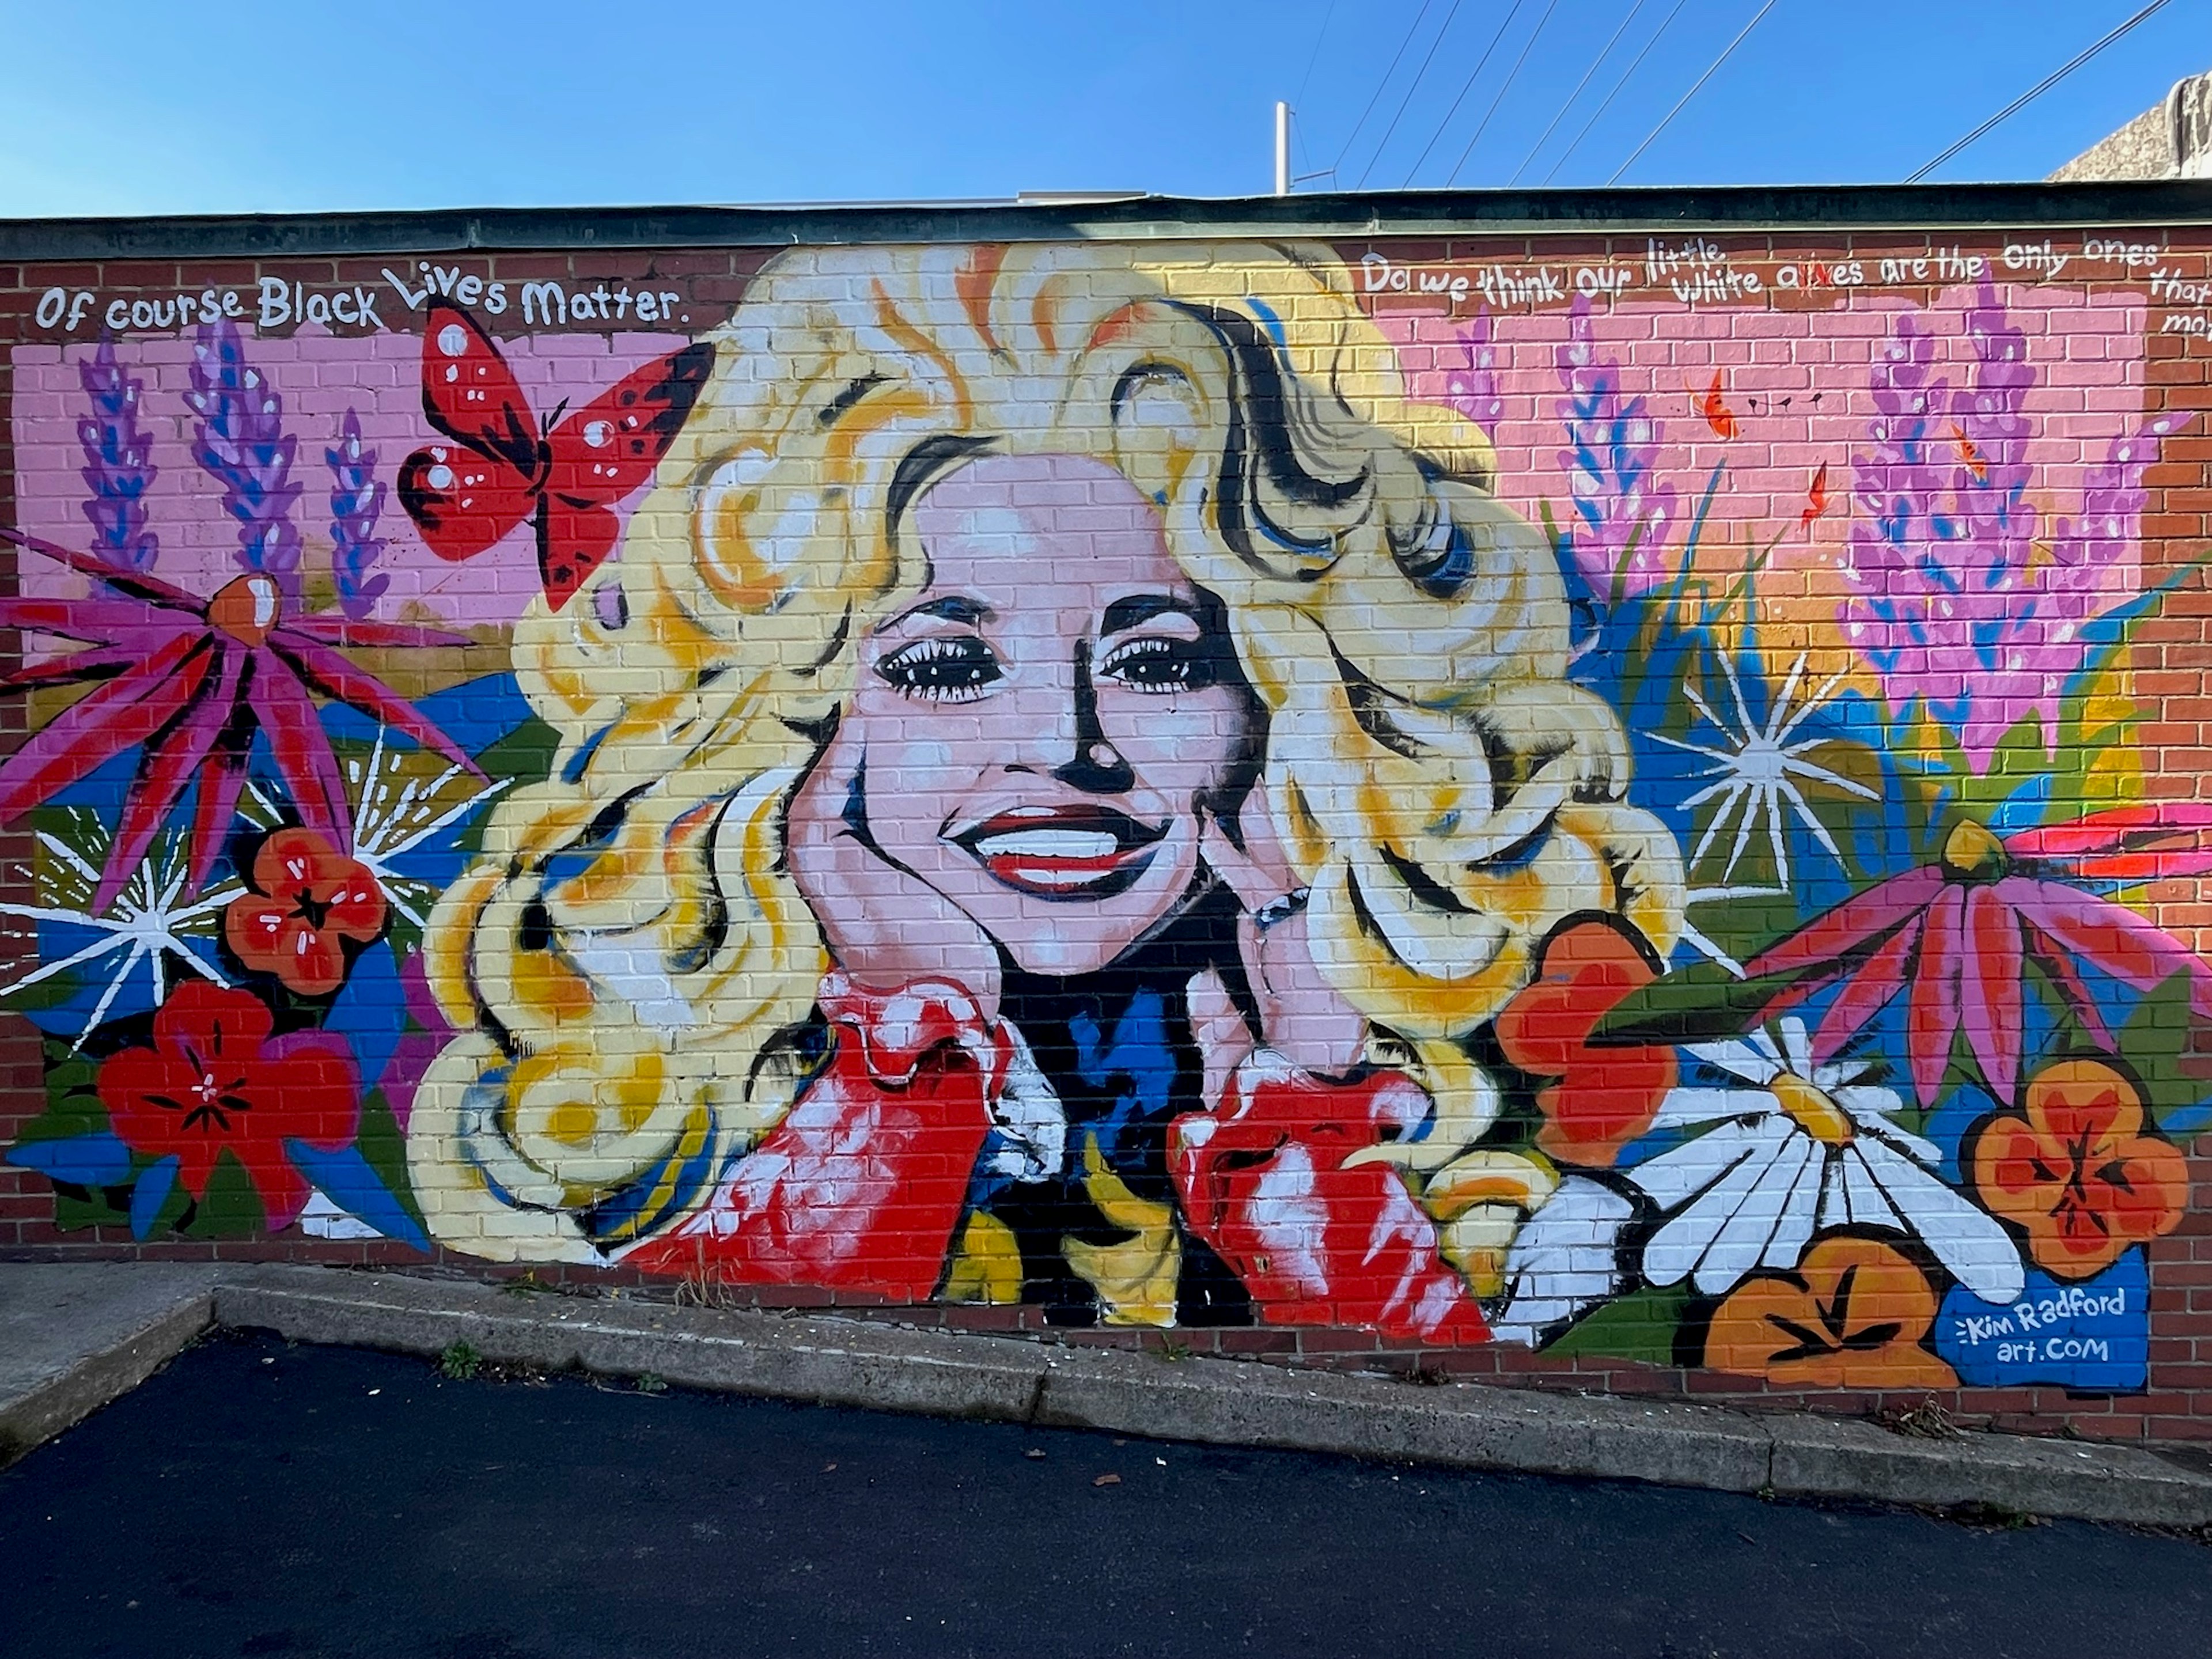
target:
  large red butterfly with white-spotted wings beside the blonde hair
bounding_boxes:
[400,301,714,611]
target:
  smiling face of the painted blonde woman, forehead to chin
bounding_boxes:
[847,456,1254,975]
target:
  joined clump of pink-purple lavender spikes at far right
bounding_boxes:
[1838,285,2179,767]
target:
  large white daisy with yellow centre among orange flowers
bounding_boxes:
[1622,1017,2024,1303]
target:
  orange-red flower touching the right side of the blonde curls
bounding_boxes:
[1498,916,1675,1168]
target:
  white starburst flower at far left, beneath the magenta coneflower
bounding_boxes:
[0,808,241,1051]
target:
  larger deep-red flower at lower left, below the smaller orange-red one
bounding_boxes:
[100,980,361,1230]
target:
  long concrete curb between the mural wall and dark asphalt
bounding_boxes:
[0,1265,2212,1527]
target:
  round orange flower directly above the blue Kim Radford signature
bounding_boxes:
[1973,1059,2190,1279]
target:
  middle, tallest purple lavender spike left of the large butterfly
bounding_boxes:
[184,319,301,604]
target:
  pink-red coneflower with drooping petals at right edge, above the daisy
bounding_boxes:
[1745,801,2212,1106]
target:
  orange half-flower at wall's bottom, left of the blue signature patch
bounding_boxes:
[1706,1232,1957,1389]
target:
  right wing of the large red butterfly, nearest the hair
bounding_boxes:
[537,340,714,611]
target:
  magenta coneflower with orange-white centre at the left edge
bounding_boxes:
[0,527,478,914]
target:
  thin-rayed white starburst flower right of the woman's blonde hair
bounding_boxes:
[1652,653,1880,887]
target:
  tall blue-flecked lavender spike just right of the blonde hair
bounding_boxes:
[1557,294,1675,597]
